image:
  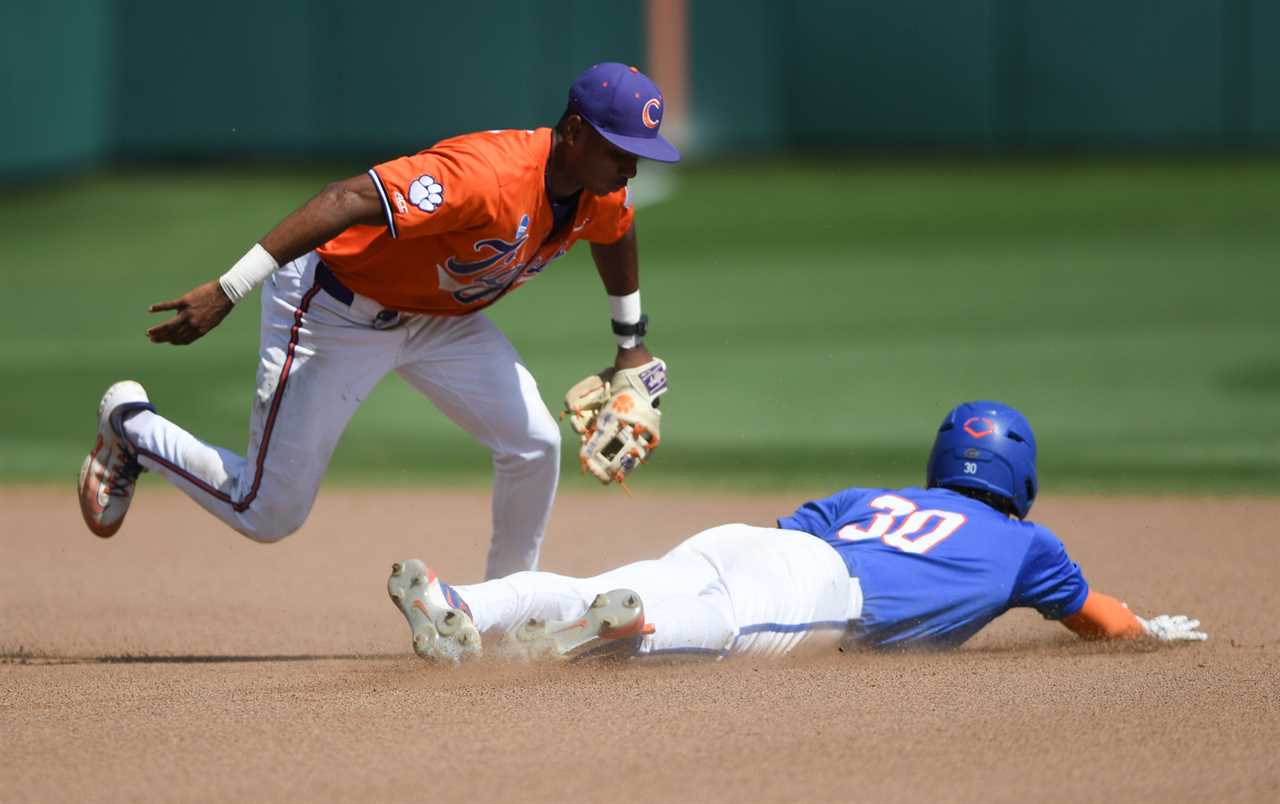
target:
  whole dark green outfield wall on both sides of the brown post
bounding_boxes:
[0,0,1280,174]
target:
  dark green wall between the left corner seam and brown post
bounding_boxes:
[115,0,644,154]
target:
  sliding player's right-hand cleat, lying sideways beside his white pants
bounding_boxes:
[499,589,654,659]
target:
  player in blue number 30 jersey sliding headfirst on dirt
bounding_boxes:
[388,402,1206,661]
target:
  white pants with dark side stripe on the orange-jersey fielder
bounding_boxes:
[124,253,559,577]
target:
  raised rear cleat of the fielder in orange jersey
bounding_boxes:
[79,380,155,539]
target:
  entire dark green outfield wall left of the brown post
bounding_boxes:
[0,0,644,175]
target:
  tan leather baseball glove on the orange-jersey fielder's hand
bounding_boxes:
[564,358,667,486]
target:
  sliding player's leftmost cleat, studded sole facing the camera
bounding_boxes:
[387,558,481,664]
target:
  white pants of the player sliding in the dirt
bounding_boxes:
[454,525,863,657]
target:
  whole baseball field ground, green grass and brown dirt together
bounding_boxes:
[0,160,1280,804]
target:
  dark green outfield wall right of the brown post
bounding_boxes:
[692,0,1280,149]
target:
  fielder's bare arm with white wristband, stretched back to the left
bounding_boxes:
[147,174,384,346]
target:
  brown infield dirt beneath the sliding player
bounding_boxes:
[0,483,1280,804]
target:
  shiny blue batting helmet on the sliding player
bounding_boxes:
[925,401,1038,519]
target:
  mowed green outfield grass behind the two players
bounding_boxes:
[0,160,1280,493]
